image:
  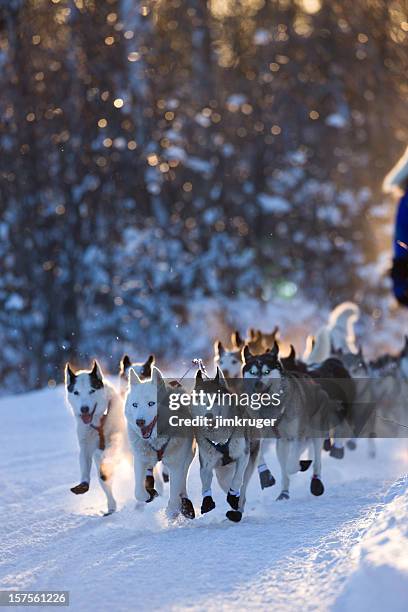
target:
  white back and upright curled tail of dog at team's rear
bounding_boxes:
[303,302,360,365]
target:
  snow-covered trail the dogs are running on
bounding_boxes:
[0,388,408,612]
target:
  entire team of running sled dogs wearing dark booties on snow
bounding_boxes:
[65,302,408,522]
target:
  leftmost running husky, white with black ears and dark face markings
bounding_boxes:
[65,361,125,514]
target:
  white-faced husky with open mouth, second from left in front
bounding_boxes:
[125,367,195,518]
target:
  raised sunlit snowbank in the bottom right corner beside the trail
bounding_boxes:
[334,476,408,612]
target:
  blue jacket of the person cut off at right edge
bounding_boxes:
[391,191,408,306]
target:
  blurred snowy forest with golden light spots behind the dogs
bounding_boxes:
[0,0,408,391]
